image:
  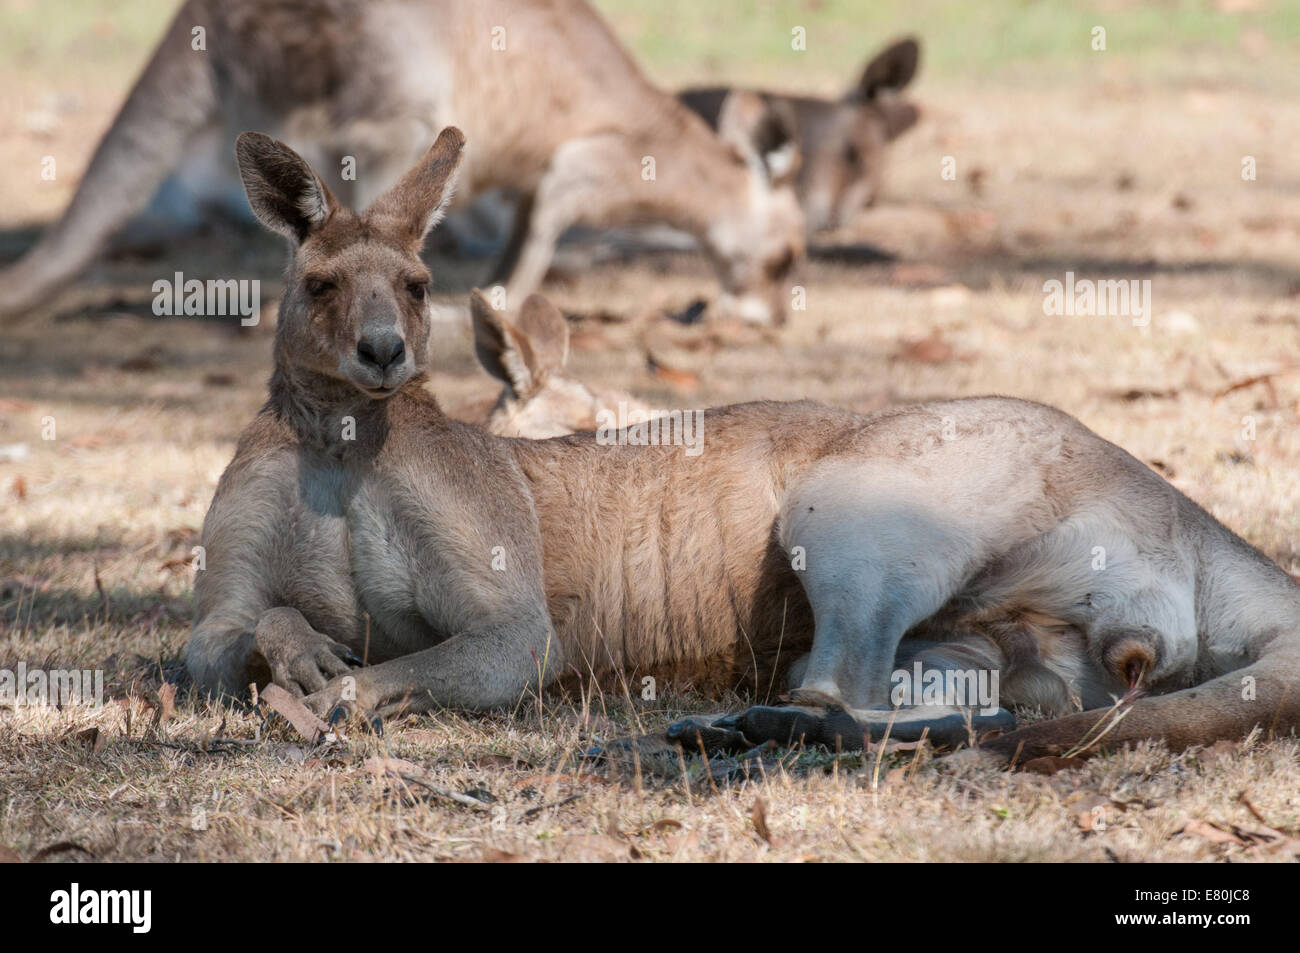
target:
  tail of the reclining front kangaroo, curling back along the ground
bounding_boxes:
[980,529,1300,762]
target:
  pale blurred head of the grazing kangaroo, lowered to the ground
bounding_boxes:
[705,90,805,324]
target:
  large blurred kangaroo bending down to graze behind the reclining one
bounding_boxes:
[0,0,803,322]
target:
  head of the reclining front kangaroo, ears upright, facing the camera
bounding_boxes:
[235,126,465,400]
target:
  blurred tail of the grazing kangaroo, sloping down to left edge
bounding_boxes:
[0,3,217,315]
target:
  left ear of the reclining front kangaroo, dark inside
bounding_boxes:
[235,133,339,242]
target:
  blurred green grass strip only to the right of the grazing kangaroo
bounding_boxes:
[595,0,1300,90]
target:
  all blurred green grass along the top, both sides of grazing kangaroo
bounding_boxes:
[0,0,1300,92]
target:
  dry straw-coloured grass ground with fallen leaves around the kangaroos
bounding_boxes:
[0,1,1300,861]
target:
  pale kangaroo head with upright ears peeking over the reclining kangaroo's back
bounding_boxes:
[469,289,632,439]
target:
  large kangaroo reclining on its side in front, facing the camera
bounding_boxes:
[187,129,1300,757]
